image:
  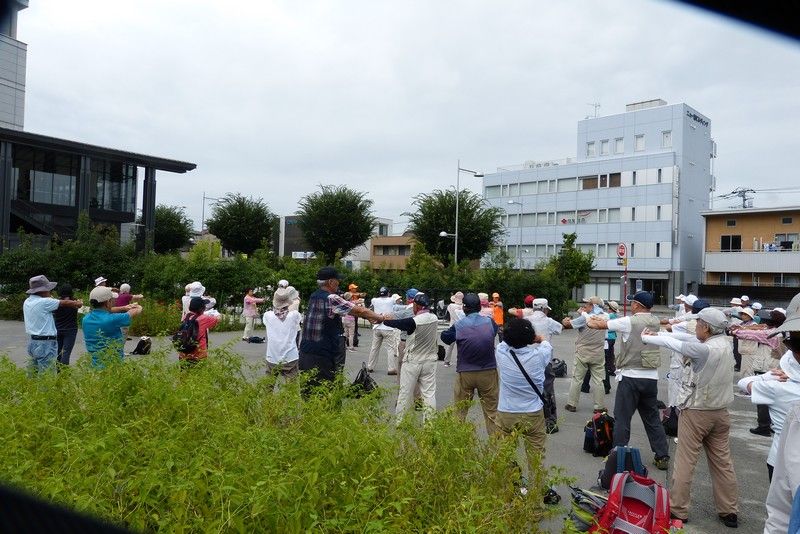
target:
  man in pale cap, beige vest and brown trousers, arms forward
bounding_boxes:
[641,308,739,528]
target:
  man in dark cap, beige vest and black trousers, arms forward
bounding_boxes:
[586,291,669,471]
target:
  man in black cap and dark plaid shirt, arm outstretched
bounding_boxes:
[299,267,383,386]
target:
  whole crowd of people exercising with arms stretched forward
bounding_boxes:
[17,267,800,532]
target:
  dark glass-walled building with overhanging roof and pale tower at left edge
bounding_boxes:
[0,0,195,252]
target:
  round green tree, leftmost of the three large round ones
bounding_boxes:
[207,193,277,254]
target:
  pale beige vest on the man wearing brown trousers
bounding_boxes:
[677,335,734,410]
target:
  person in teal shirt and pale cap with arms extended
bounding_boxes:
[81,285,142,369]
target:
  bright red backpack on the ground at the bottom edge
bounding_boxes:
[589,471,683,534]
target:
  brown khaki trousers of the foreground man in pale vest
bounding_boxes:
[670,408,739,517]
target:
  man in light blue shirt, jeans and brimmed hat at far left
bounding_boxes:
[22,274,83,373]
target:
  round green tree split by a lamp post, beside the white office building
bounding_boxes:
[406,189,505,266]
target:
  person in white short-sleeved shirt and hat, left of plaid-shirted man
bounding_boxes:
[263,287,302,380]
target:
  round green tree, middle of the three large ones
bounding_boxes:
[297,185,376,264]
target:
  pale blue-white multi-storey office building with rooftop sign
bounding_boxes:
[483,99,716,303]
